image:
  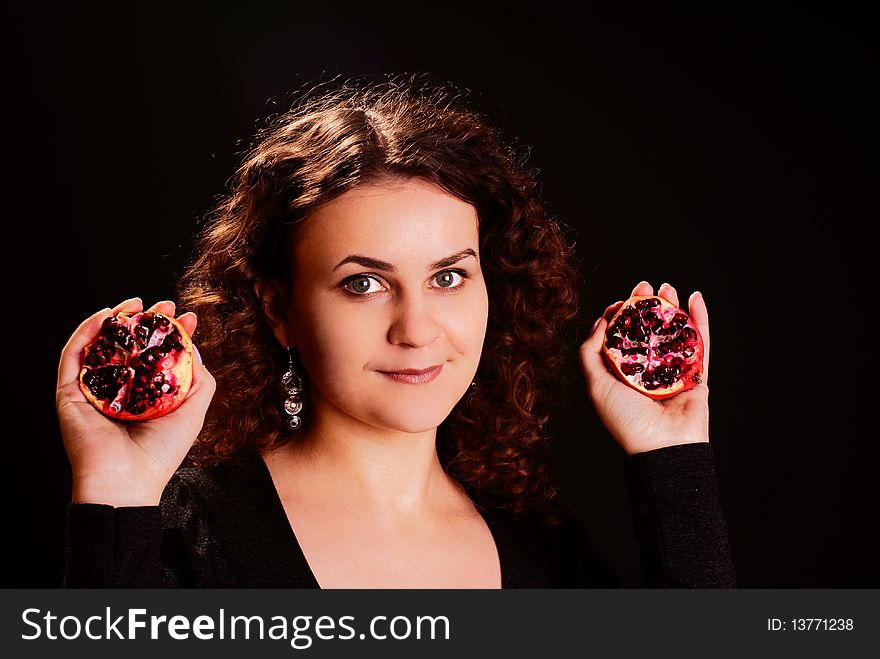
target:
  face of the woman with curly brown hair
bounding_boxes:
[282,179,489,432]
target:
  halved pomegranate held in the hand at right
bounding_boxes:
[602,295,703,400]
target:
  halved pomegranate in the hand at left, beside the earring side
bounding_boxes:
[79,311,193,421]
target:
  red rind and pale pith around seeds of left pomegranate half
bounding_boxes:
[79,312,193,421]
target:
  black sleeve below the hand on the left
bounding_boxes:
[63,476,211,588]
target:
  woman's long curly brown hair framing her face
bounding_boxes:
[179,75,580,522]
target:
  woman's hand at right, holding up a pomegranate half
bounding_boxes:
[580,281,709,455]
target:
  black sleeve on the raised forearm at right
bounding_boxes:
[624,442,736,588]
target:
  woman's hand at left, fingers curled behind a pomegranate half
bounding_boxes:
[55,298,215,507]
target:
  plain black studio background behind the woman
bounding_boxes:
[3,2,880,588]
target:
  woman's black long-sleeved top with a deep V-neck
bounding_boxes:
[64,443,736,588]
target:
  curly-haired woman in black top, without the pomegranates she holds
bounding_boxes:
[57,79,735,588]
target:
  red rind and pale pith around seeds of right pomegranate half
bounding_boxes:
[602,295,703,400]
